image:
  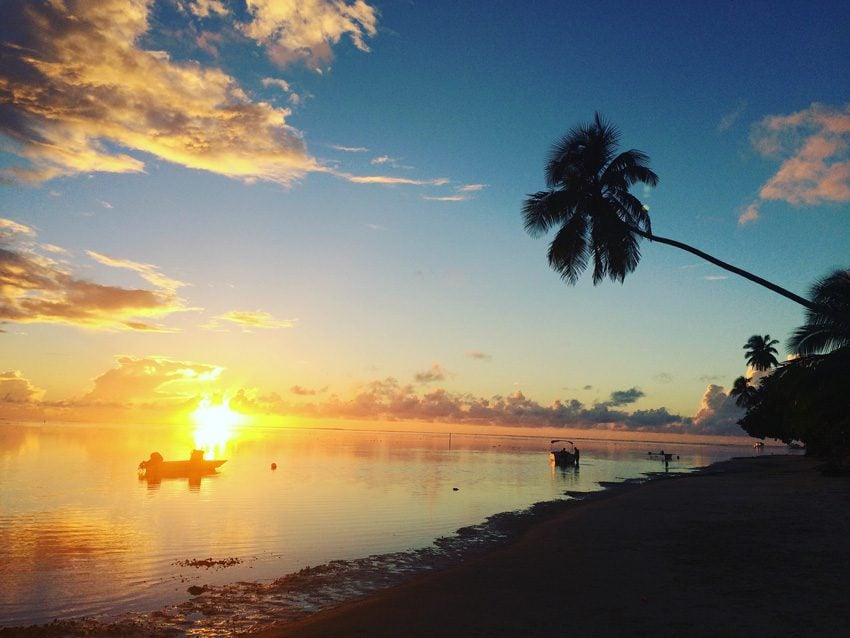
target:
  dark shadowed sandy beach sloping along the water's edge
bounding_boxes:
[256,456,850,638]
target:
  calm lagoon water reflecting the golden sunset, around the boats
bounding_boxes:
[0,425,753,626]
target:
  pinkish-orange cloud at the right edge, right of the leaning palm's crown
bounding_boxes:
[751,103,850,206]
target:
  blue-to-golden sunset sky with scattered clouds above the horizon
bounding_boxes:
[0,0,850,434]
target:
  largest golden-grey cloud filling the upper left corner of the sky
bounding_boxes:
[0,0,322,185]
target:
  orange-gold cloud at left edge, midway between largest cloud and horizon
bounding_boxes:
[0,220,186,330]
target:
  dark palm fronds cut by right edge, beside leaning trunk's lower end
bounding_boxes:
[788,270,850,355]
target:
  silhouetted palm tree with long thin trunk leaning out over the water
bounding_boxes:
[522,113,814,316]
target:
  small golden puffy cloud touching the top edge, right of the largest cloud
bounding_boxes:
[242,0,377,71]
